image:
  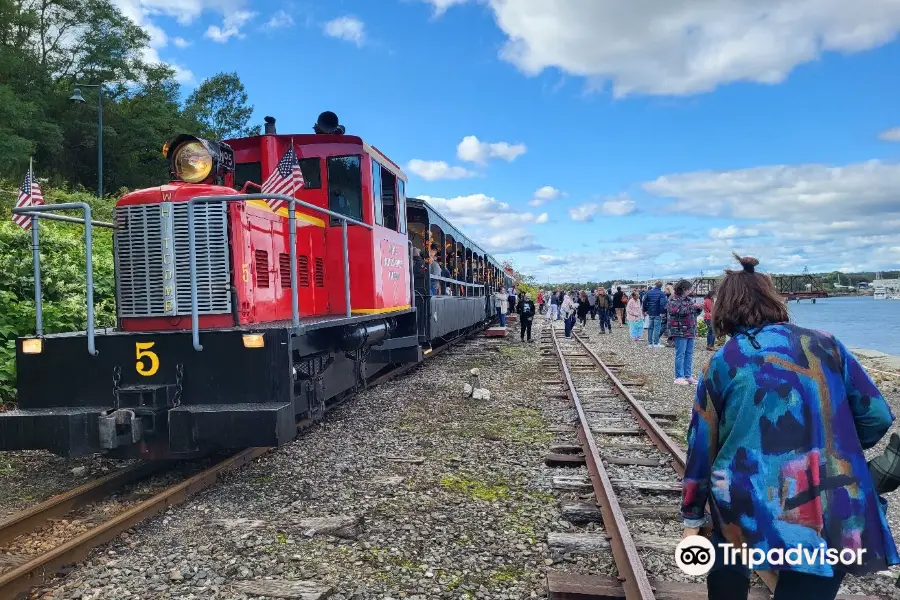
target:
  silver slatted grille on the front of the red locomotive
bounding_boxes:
[115,202,231,317]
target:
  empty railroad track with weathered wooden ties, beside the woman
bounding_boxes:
[541,324,876,600]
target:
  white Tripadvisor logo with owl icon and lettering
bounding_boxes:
[675,535,866,576]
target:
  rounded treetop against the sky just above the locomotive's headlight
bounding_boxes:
[184,73,259,140]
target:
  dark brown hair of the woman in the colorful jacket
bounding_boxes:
[712,254,789,335]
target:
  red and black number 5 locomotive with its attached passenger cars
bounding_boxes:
[0,113,508,458]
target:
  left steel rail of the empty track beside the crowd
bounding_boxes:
[550,326,656,600]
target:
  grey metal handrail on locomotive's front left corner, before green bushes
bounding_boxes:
[12,202,115,356]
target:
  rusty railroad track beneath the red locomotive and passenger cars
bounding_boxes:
[0,329,481,600]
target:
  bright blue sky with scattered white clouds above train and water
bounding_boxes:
[115,0,900,281]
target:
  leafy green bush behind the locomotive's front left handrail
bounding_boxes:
[0,182,116,404]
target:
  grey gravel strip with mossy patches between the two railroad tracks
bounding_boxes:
[26,328,569,600]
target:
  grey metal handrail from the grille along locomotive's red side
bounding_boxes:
[188,194,374,352]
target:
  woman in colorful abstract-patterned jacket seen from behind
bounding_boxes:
[681,257,900,600]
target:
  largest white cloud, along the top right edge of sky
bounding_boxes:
[430,0,900,96]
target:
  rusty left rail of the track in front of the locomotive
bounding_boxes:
[0,462,163,546]
